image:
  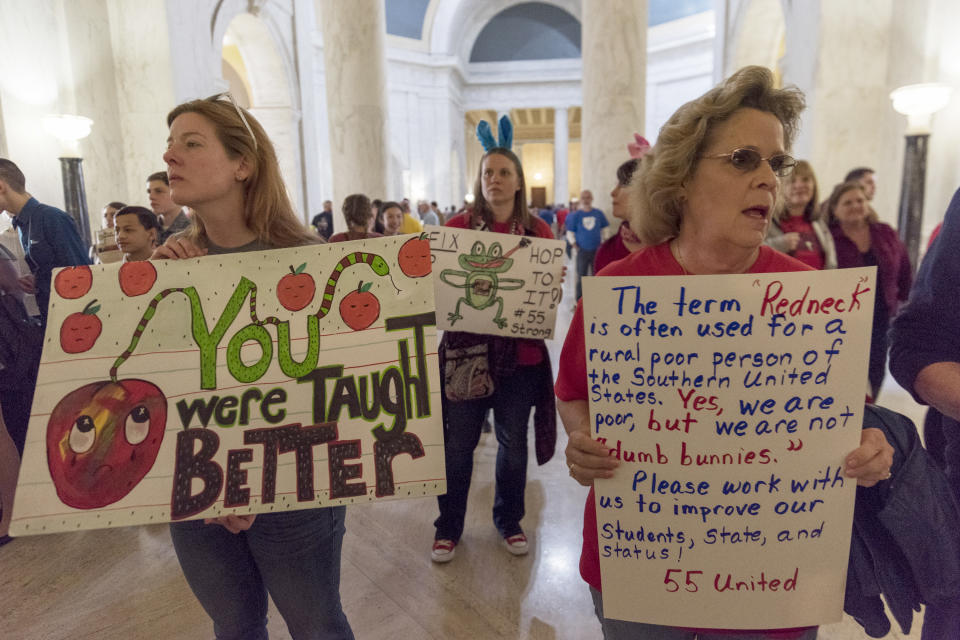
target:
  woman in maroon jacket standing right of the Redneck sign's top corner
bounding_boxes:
[826,182,913,401]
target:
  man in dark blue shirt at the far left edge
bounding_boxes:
[0,158,90,325]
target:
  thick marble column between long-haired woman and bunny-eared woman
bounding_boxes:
[319,0,389,225]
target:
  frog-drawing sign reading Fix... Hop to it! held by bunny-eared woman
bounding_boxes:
[425,225,564,339]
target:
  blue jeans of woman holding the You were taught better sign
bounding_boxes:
[170,507,353,640]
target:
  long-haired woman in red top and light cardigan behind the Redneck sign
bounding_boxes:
[767,160,837,269]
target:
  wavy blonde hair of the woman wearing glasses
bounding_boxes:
[630,66,805,245]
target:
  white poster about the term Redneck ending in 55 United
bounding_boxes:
[584,268,876,629]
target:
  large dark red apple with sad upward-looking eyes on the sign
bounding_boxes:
[47,379,167,509]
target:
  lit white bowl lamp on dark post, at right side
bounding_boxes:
[890,83,952,269]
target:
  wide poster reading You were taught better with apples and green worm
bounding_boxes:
[11,236,446,535]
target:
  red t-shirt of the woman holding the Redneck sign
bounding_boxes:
[554,242,812,640]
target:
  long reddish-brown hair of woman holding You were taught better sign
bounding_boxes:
[167,93,319,248]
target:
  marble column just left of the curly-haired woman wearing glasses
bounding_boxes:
[580,0,647,226]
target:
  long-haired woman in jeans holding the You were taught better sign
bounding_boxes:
[153,95,353,639]
